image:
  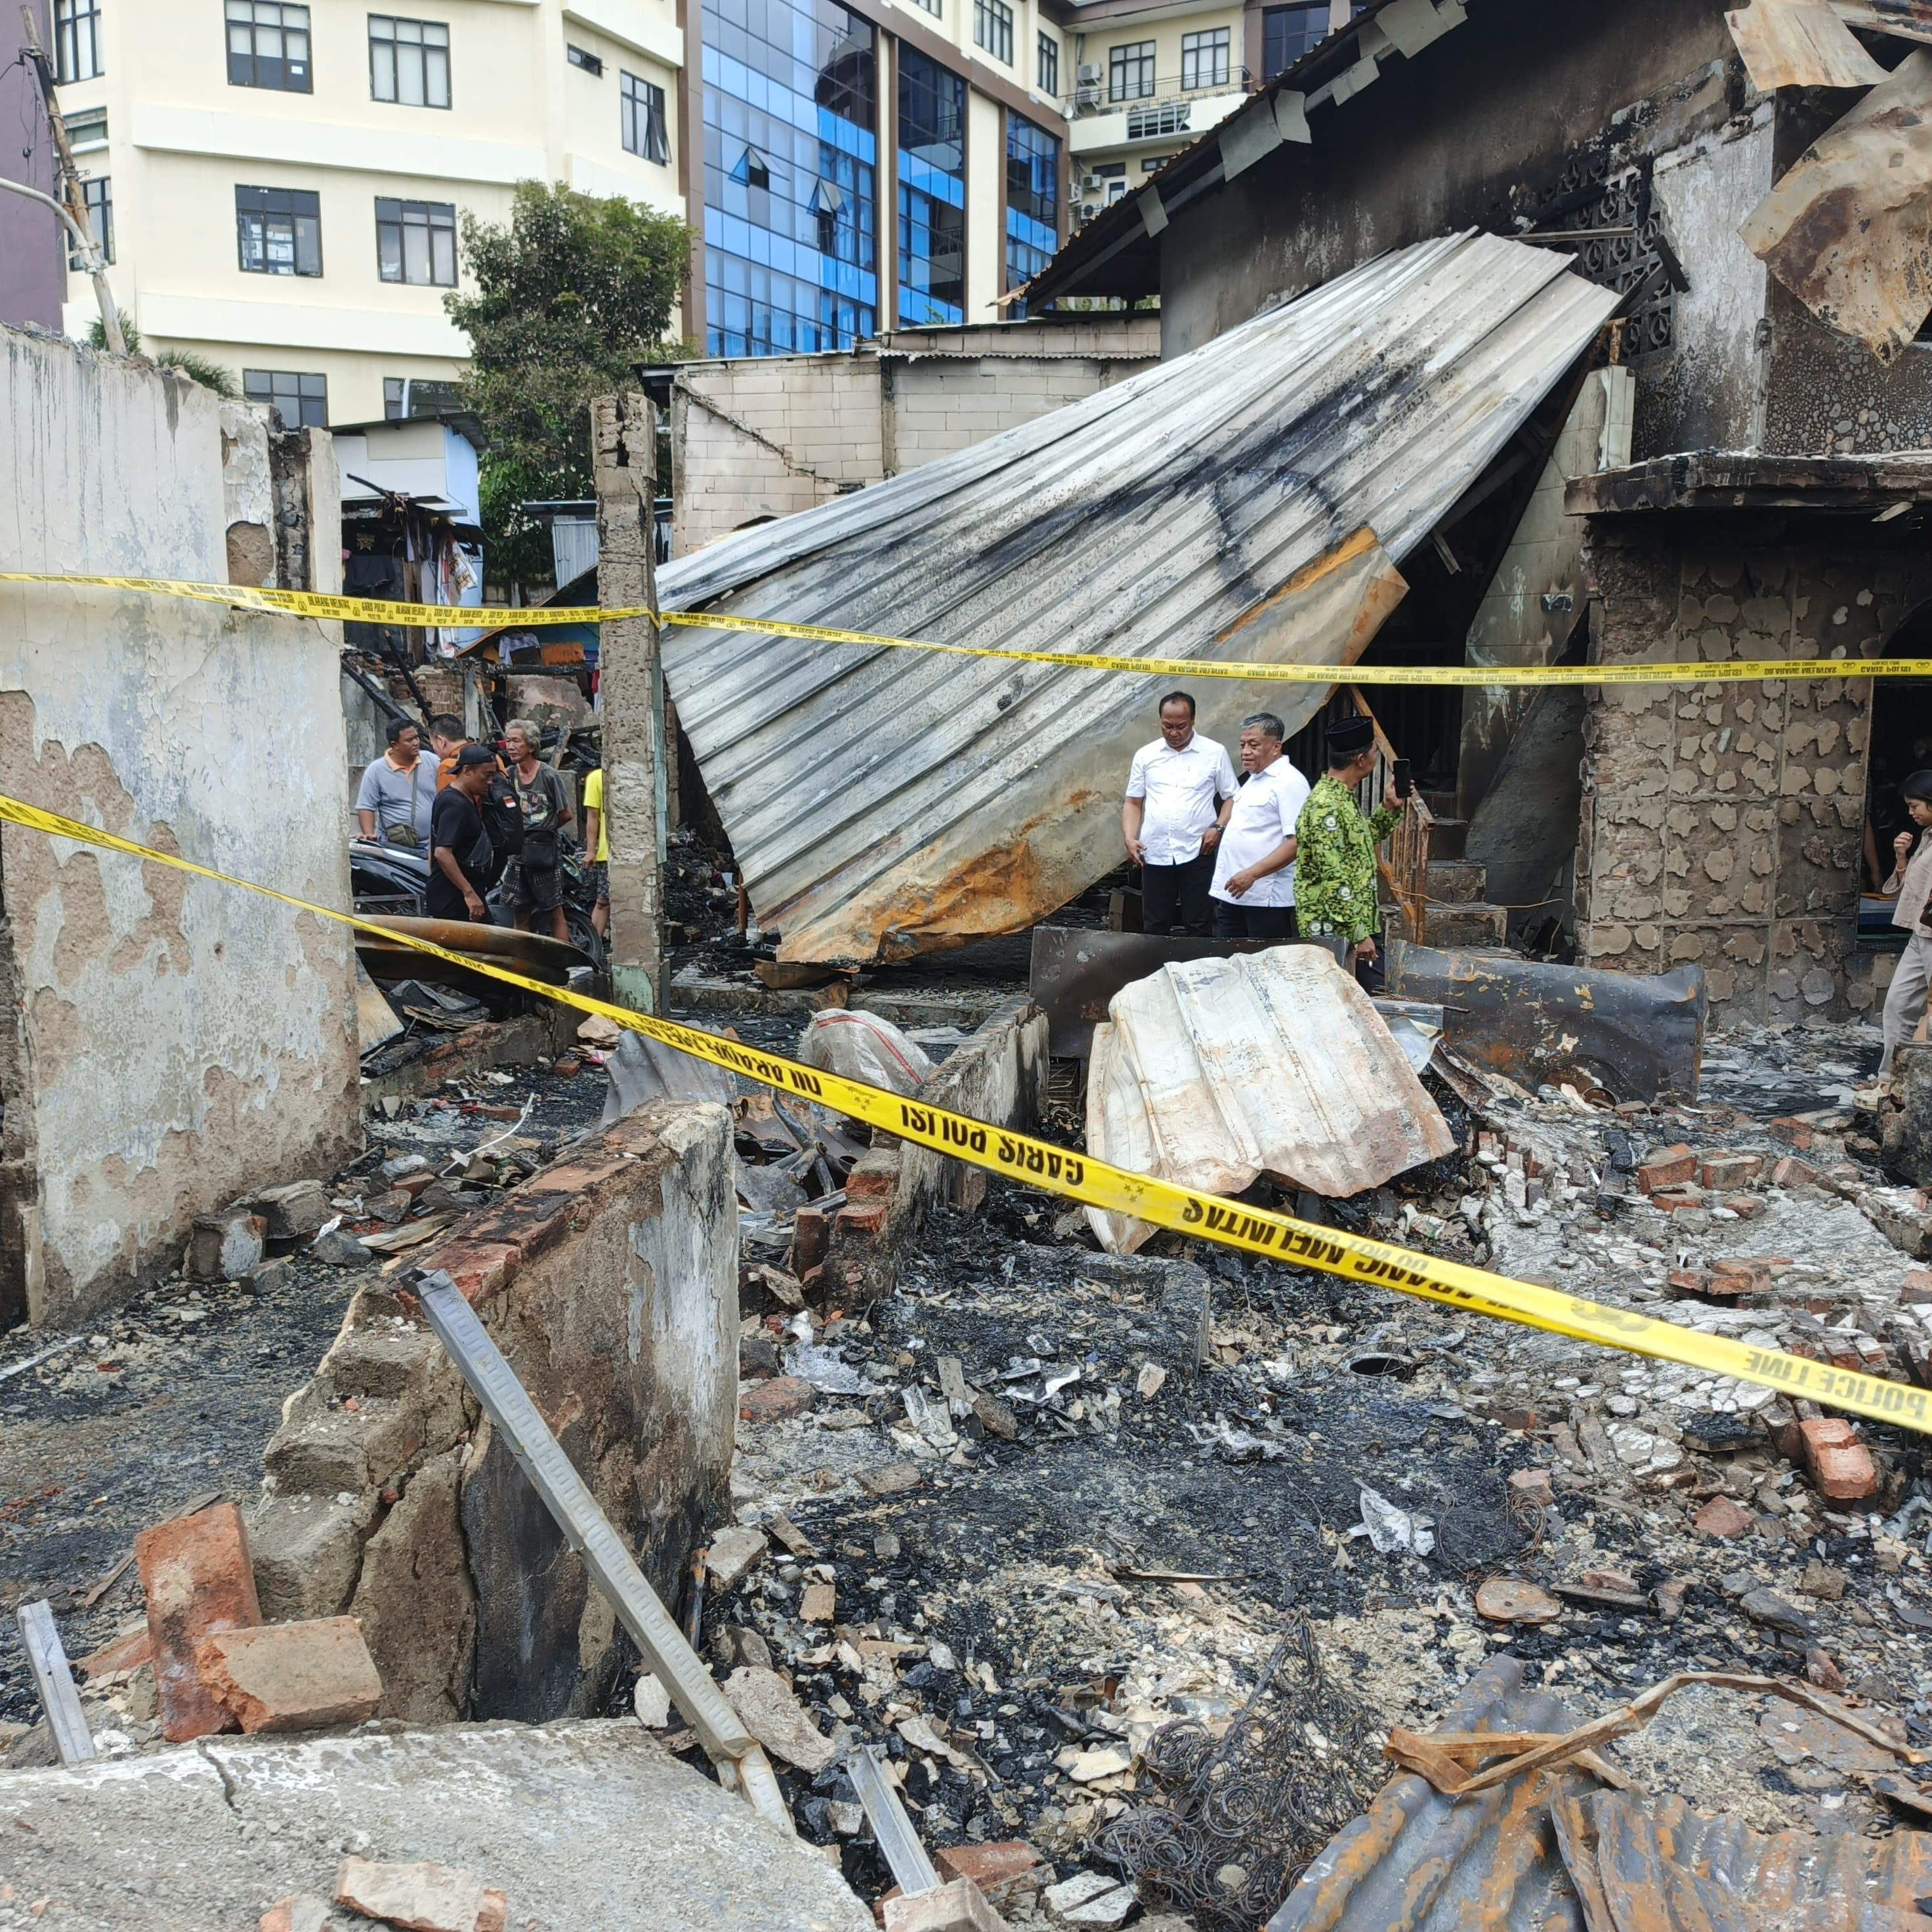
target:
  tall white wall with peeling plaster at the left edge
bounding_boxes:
[0,330,362,1326]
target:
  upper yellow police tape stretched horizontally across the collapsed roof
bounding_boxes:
[0,570,1932,686]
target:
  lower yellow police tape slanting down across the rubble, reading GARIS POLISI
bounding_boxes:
[0,796,1932,1435]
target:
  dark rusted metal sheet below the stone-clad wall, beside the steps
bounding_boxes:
[1387,939,1708,1099]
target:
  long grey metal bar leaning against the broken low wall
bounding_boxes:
[410,1269,792,1832]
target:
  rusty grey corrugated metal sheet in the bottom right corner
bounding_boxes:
[1267,1658,1932,1932]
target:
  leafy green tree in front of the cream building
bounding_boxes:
[444,182,692,581]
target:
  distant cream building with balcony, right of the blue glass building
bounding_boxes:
[1059,0,1366,228]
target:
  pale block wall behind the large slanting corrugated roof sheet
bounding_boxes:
[671,315,1159,556]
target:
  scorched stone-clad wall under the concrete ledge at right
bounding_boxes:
[1576,530,1932,1024]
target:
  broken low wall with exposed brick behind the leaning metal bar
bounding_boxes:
[249,1101,738,1723]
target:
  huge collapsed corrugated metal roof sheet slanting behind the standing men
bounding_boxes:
[659,234,1617,964]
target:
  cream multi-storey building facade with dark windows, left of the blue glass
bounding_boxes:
[52,0,686,423]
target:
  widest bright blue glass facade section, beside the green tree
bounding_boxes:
[704,0,877,356]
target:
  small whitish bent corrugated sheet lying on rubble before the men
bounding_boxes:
[1087,945,1457,1254]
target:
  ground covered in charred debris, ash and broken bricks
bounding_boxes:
[0,1020,1932,1932]
